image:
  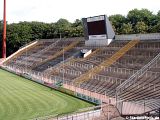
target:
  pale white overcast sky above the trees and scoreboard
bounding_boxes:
[0,0,160,23]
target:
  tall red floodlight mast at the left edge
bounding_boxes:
[2,0,6,58]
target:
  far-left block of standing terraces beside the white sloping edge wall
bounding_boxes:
[3,39,57,69]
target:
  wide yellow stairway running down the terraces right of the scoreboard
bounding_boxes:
[74,40,139,85]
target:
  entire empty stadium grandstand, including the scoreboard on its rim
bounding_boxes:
[1,16,160,120]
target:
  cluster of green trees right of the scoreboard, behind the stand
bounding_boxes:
[109,9,160,34]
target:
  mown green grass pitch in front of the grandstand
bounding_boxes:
[0,69,93,120]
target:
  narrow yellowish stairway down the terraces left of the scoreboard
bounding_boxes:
[30,40,80,69]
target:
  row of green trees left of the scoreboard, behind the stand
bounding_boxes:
[0,19,83,56]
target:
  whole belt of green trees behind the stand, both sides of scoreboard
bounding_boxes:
[0,9,160,55]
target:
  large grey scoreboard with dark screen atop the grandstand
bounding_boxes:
[82,15,115,40]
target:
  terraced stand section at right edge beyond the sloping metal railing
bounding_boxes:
[116,53,160,114]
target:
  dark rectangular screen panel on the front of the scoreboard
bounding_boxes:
[87,20,106,35]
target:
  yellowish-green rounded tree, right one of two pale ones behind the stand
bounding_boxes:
[135,22,148,33]
